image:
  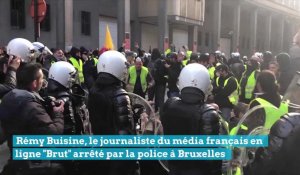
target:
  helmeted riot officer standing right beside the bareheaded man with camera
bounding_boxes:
[47,61,91,134]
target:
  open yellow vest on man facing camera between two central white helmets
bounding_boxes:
[129,66,149,92]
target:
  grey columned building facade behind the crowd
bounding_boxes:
[0,0,300,56]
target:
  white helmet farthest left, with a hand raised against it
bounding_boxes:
[7,38,35,63]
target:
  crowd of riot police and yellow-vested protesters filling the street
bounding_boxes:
[0,38,300,175]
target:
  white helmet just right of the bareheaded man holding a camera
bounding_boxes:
[49,61,76,88]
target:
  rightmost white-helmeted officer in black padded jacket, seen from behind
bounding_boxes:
[161,63,221,174]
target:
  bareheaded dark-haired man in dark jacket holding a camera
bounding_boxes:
[0,63,64,175]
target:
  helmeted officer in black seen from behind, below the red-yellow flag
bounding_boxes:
[88,51,135,174]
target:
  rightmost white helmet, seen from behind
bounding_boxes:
[178,63,211,95]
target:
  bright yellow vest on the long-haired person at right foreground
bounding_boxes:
[250,98,288,129]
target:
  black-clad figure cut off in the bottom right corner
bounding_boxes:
[250,113,300,175]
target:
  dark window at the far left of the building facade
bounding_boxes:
[10,0,25,29]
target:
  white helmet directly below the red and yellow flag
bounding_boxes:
[97,50,128,82]
